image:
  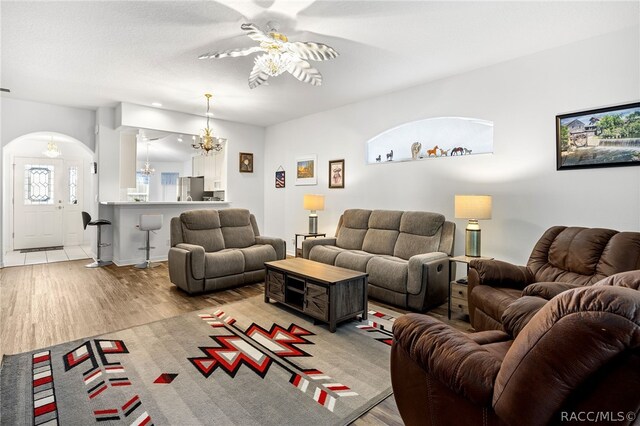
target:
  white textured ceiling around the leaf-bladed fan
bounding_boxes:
[0,0,640,126]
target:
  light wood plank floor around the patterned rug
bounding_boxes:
[0,259,470,426]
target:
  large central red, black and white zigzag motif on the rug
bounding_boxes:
[189,310,358,411]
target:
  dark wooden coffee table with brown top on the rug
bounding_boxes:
[264,257,368,333]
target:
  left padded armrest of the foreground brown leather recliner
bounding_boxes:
[393,314,501,404]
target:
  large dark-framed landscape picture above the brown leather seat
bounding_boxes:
[556,102,640,170]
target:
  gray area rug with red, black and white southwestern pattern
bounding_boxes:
[0,296,399,425]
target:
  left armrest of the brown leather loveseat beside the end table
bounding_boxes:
[468,259,534,292]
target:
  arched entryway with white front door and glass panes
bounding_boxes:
[2,132,95,264]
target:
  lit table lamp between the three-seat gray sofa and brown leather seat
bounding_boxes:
[455,195,491,257]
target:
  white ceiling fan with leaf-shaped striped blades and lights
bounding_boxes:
[198,22,339,89]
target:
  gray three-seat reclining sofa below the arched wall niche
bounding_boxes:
[302,209,455,311]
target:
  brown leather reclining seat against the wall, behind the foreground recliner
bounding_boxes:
[468,226,640,331]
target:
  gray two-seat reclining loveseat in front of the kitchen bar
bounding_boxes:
[169,209,286,294]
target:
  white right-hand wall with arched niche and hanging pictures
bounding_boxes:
[257,27,640,264]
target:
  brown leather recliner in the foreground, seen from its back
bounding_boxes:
[391,285,640,426]
